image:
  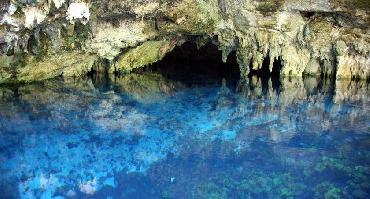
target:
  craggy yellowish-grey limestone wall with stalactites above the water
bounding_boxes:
[0,0,370,83]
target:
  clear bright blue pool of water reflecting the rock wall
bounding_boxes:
[0,73,370,199]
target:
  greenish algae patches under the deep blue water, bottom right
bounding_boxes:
[189,157,369,199]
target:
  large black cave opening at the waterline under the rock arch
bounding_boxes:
[135,42,240,86]
